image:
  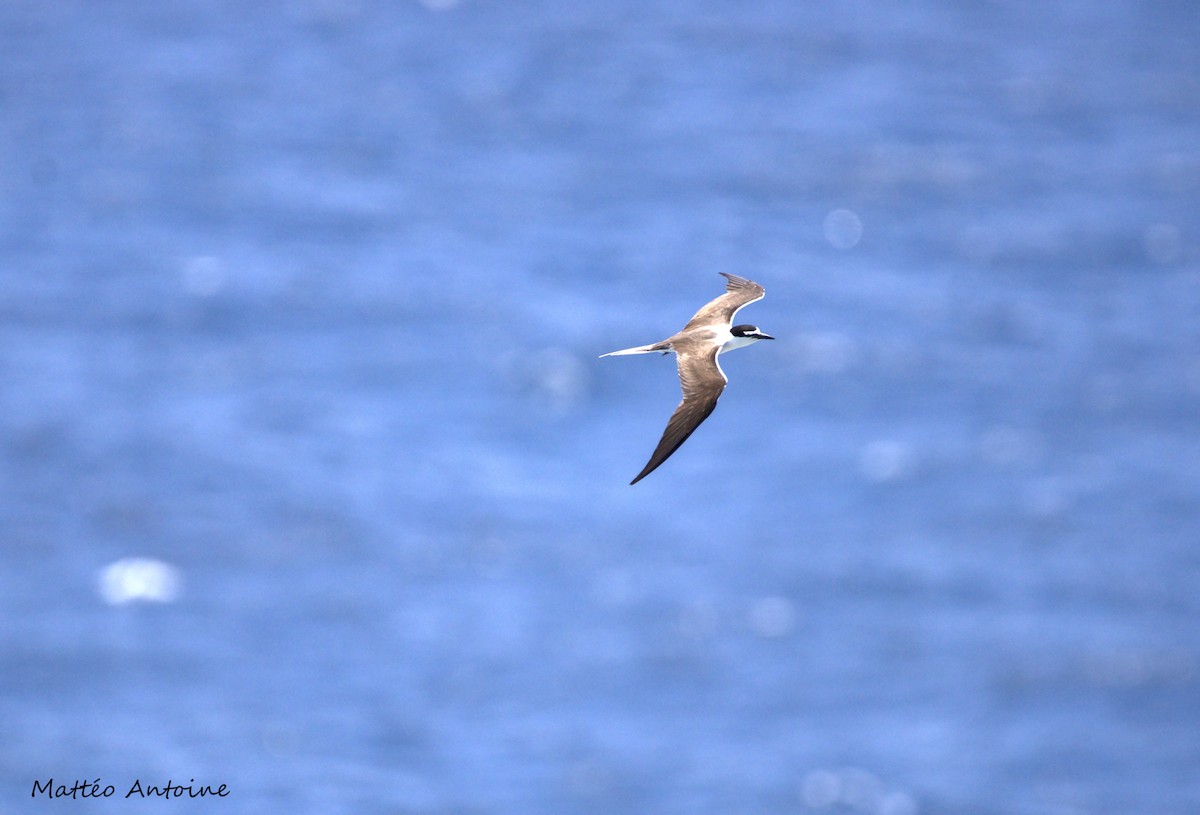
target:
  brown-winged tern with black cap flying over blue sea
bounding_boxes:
[600,271,775,485]
